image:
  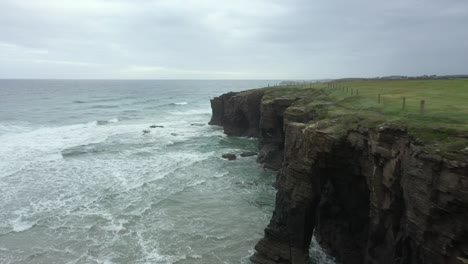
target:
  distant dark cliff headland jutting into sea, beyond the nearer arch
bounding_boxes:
[209,90,298,170]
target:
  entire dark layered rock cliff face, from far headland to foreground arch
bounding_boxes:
[212,91,468,264]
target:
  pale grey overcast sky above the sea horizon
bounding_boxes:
[0,0,468,79]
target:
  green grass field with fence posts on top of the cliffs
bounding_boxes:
[264,78,468,155]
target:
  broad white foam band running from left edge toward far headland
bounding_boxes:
[0,116,216,175]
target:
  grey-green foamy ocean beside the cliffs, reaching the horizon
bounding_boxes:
[0,80,332,264]
